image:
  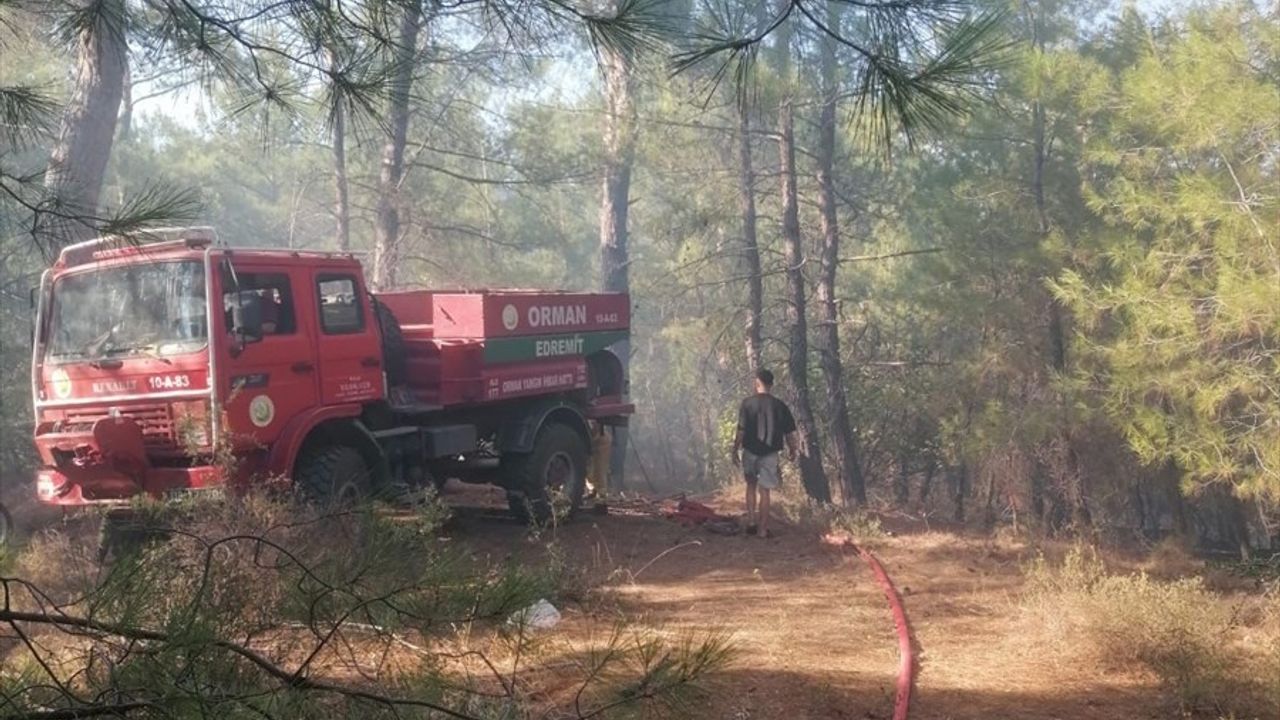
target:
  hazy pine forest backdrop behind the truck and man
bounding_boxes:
[0,0,1280,542]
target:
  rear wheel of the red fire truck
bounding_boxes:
[504,423,588,525]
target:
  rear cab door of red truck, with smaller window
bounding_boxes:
[311,269,383,405]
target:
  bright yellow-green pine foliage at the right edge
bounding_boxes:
[1056,4,1280,498]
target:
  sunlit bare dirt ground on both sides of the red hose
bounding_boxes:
[449,486,1275,720]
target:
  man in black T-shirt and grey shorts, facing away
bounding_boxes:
[733,369,796,538]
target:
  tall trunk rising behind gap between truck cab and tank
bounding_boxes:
[371,0,422,290]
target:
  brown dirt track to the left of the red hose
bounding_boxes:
[565,509,896,720]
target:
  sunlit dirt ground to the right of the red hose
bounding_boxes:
[877,520,1175,720]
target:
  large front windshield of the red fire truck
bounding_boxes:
[47,260,209,363]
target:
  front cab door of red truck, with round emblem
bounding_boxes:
[216,263,319,446]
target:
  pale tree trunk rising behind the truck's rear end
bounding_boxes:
[600,41,636,489]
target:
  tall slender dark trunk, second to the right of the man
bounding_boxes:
[818,3,867,506]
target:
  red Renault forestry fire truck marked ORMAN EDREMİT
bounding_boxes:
[32,228,634,519]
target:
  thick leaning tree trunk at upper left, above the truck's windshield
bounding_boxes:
[40,0,128,246]
